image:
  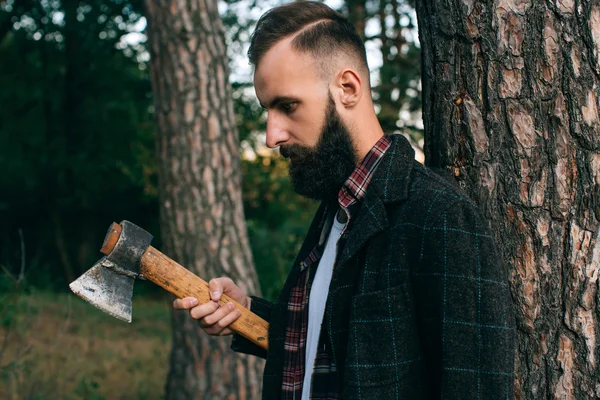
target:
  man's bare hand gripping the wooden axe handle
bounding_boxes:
[173,278,250,336]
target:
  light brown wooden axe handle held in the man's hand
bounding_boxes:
[100,223,269,350]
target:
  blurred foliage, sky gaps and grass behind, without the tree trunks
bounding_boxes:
[0,0,423,399]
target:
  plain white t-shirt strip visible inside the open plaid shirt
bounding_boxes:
[302,212,345,400]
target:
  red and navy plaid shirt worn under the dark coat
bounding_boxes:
[281,136,391,400]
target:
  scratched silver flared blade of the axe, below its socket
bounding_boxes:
[69,258,135,322]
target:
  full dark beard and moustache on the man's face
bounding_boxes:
[279,96,356,201]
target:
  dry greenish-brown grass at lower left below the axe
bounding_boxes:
[0,288,171,400]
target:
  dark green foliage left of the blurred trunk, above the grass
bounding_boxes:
[0,0,157,287]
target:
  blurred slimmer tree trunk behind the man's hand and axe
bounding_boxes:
[145,0,263,400]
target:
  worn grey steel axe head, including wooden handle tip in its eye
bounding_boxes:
[69,221,152,322]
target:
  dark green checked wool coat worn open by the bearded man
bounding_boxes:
[232,135,515,400]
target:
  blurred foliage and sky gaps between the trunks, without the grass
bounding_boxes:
[0,0,422,298]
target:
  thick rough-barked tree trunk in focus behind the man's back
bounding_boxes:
[417,0,600,399]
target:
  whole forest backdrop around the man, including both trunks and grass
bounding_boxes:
[0,0,600,400]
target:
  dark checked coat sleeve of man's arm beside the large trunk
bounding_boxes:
[414,199,515,400]
